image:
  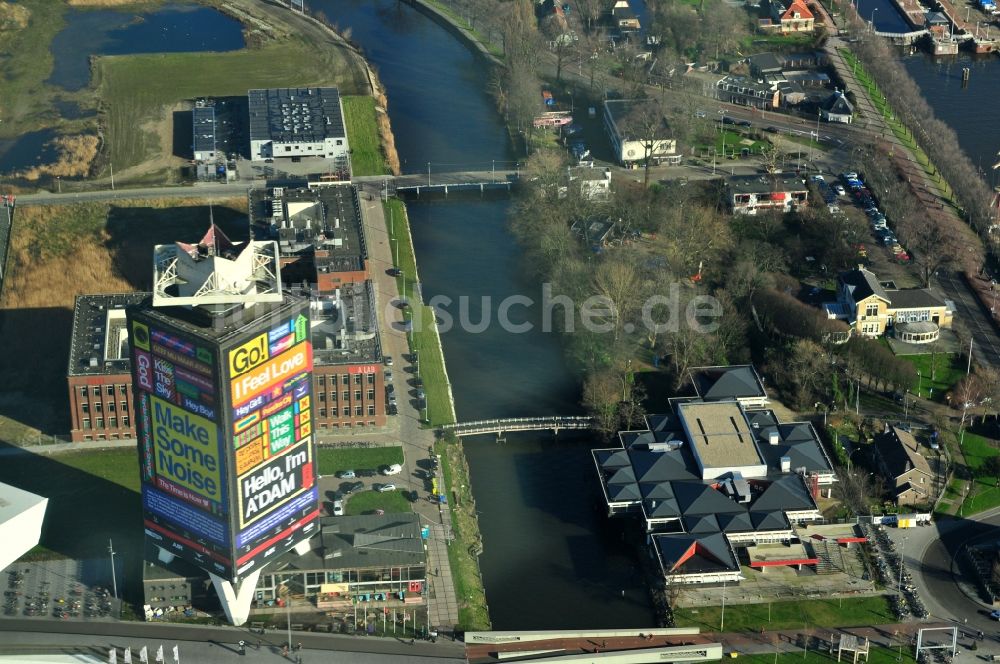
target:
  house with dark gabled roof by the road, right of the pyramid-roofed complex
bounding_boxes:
[875,426,934,505]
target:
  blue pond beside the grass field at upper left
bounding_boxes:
[46,4,244,91]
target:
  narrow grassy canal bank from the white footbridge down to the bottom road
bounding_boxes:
[434,438,490,630]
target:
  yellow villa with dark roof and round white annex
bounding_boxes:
[823,265,955,343]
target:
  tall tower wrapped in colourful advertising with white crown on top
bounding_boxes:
[127,224,319,625]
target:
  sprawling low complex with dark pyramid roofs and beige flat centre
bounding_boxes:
[592,384,837,583]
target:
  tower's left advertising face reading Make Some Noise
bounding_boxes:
[129,318,233,576]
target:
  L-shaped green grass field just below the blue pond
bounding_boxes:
[95,40,368,171]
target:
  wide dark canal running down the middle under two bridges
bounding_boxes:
[310,0,654,629]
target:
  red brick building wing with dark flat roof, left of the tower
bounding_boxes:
[67,293,149,442]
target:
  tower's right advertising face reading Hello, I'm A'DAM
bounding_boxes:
[224,314,319,574]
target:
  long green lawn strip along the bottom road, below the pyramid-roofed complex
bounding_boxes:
[674,596,896,633]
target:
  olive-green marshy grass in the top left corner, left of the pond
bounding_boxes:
[0,0,67,137]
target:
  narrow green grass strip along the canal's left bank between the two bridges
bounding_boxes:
[384,199,455,427]
